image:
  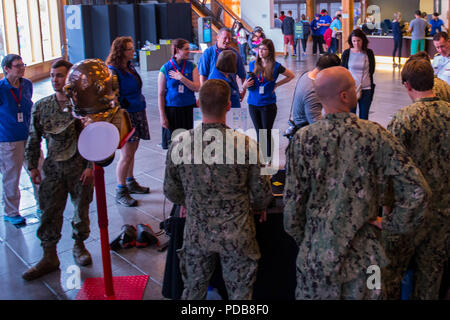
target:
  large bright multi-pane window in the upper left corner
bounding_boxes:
[0,0,61,65]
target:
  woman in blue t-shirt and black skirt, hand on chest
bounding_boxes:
[158,39,200,149]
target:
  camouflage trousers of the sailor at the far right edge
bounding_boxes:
[383,217,450,300]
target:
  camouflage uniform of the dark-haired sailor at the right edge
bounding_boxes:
[388,97,450,299]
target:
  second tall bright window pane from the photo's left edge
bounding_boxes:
[16,0,33,63]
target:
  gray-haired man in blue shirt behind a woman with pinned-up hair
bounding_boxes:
[198,28,246,101]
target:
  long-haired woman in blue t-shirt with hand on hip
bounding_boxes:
[243,39,295,157]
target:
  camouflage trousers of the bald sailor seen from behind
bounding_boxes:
[295,268,383,300]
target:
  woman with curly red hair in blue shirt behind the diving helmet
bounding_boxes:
[106,37,150,207]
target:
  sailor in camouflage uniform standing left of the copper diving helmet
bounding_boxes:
[22,60,93,280]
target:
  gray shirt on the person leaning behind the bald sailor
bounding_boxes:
[292,72,322,125]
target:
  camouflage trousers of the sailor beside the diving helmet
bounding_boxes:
[37,153,93,247]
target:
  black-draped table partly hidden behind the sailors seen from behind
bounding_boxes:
[162,198,298,300]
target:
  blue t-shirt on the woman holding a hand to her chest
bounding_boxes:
[160,59,195,107]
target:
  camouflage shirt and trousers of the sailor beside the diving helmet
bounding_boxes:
[25,95,93,247]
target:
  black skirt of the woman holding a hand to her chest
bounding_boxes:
[161,104,196,149]
